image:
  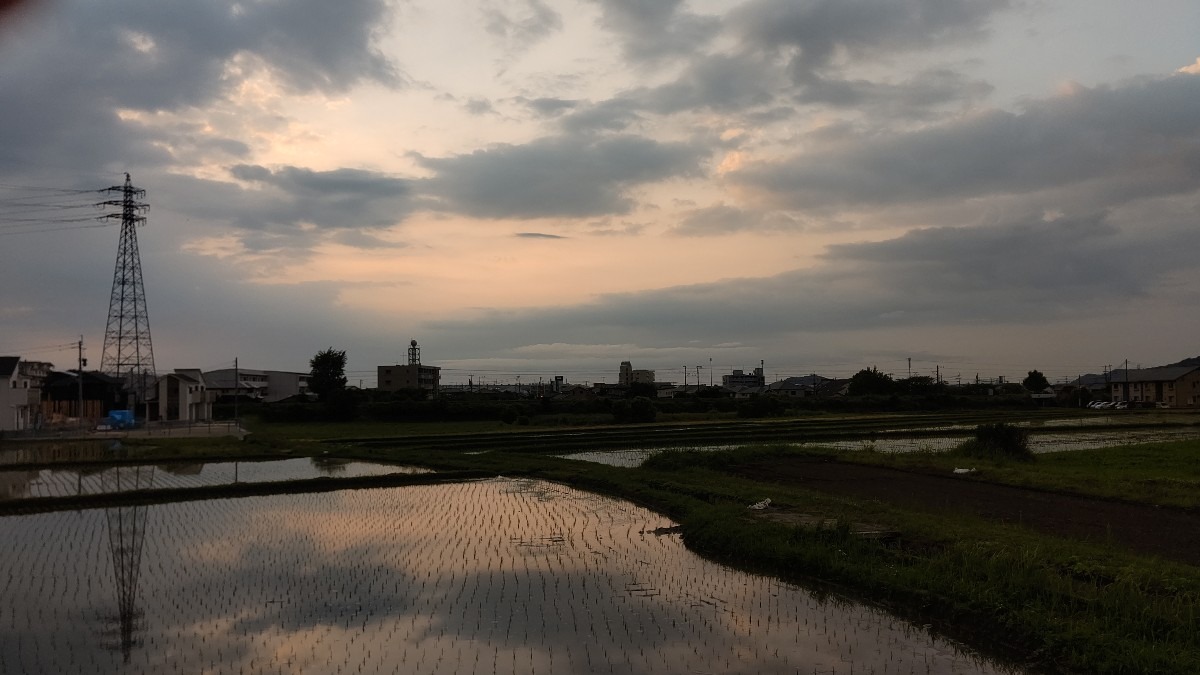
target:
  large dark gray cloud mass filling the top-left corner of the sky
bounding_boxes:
[0,0,403,180]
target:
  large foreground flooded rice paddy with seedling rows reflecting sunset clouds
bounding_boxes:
[0,478,1013,674]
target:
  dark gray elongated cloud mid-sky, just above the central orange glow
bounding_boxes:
[419,136,706,219]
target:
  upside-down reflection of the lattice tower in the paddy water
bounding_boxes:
[104,466,154,663]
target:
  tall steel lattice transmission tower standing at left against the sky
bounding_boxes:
[97,174,155,407]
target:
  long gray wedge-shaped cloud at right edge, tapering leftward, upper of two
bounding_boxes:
[731,74,1200,208]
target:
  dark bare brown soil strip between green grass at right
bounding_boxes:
[738,458,1200,565]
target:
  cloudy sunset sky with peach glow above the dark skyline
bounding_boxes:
[0,0,1200,387]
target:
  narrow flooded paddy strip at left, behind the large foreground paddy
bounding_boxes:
[0,458,431,501]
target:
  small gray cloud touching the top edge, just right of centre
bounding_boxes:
[583,0,720,64]
